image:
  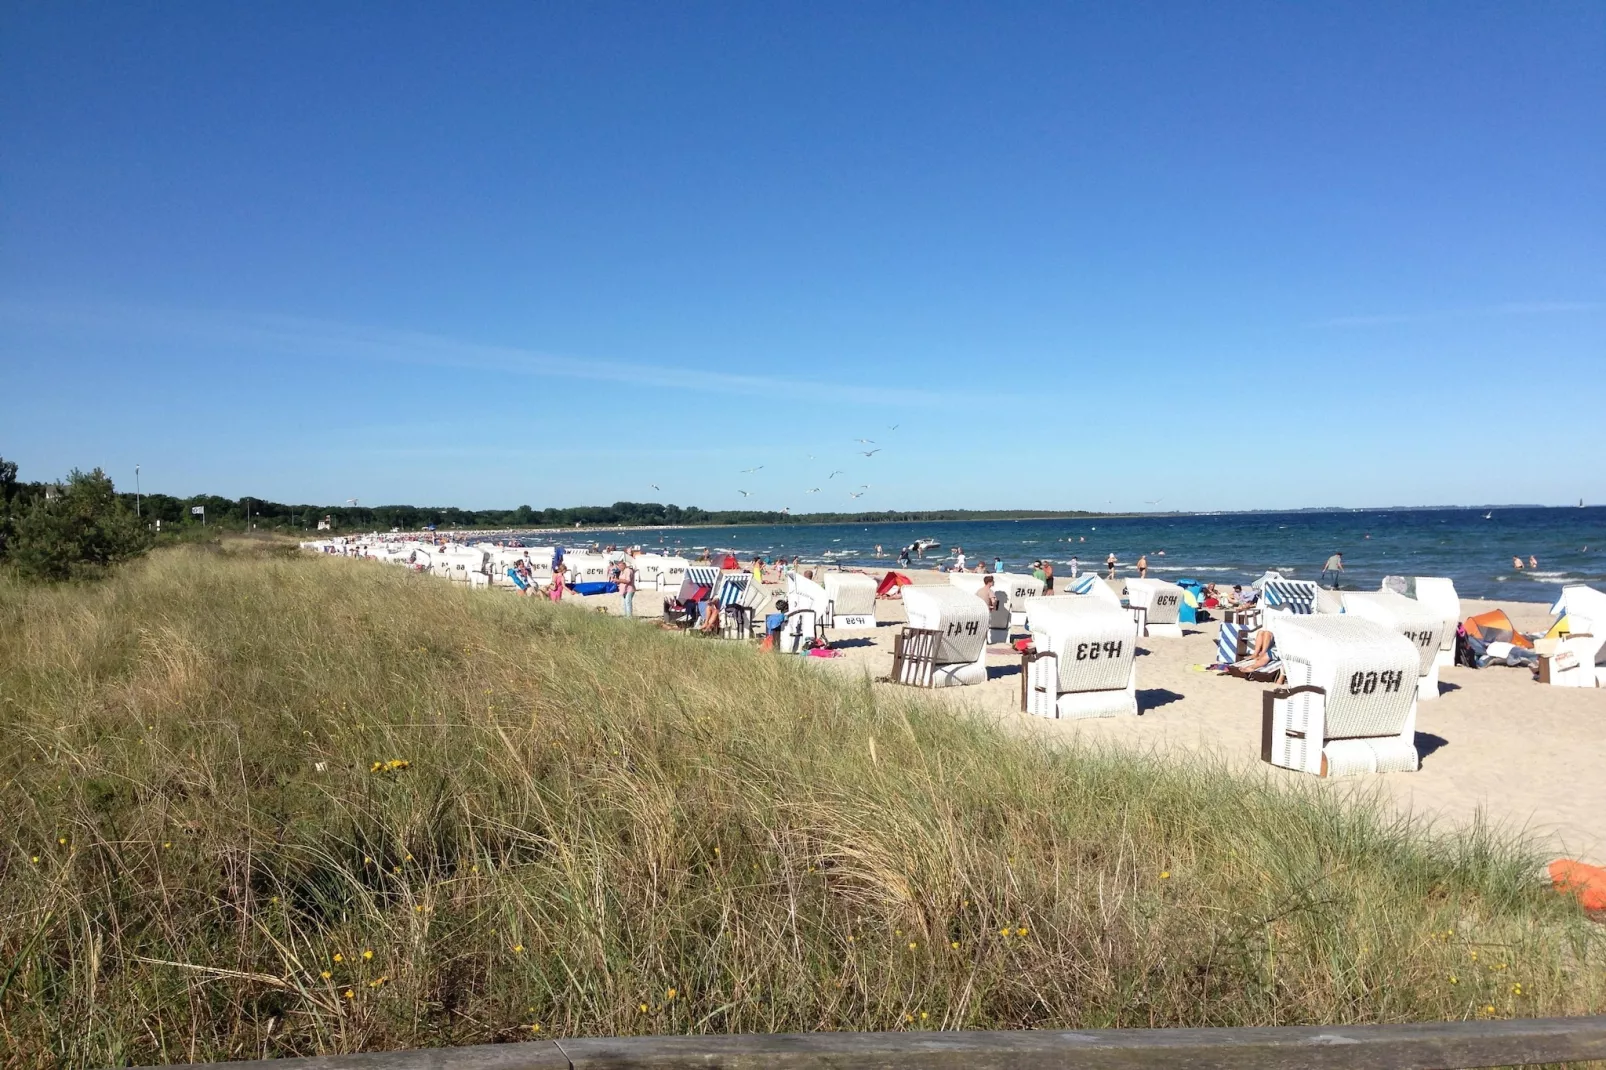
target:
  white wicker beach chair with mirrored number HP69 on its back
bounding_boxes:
[1261,614,1421,776]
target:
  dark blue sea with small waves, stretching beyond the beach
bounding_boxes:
[507,506,1606,602]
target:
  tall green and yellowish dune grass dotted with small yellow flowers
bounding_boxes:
[0,546,1606,1067]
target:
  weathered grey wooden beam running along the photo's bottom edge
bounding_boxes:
[144,1015,1606,1070]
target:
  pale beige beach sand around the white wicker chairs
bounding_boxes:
[565,570,1606,864]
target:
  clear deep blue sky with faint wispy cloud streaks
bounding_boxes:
[0,0,1606,511]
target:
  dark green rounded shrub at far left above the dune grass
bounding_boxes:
[8,468,151,582]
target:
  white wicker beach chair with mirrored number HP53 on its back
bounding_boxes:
[1021,598,1137,718]
